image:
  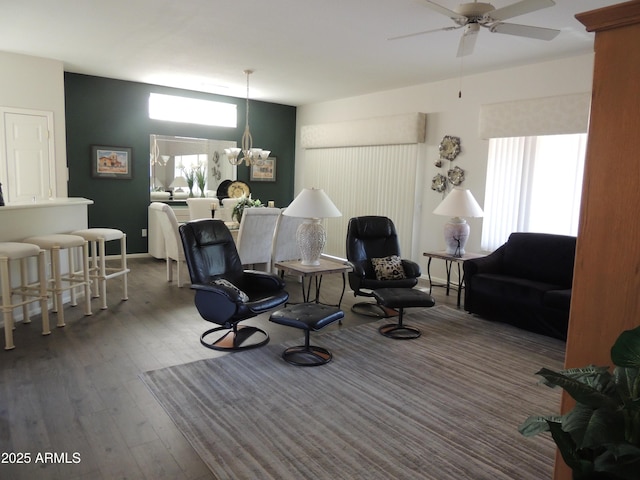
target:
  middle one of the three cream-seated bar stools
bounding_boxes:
[24,233,91,327]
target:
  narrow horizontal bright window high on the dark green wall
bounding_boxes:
[149,93,238,128]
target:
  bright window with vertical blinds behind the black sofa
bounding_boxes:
[481,133,587,251]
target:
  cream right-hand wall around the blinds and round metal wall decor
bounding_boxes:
[295,54,593,276]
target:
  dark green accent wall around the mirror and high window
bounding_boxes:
[64,73,296,253]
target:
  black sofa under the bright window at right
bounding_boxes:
[463,233,576,340]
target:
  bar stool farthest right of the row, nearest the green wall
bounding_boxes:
[71,228,131,310]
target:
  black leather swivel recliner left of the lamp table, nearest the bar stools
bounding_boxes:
[179,219,289,350]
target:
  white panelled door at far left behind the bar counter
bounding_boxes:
[3,110,55,202]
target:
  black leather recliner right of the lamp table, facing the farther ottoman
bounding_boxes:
[347,216,421,317]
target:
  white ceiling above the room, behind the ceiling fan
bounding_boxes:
[0,0,621,106]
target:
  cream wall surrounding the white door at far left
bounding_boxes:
[0,52,68,197]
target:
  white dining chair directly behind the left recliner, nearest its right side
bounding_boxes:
[236,207,280,272]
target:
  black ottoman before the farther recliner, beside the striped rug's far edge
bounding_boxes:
[373,288,436,340]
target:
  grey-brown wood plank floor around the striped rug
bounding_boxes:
[0,258,456,480]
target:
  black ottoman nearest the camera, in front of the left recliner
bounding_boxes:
[269,303,344,367]
